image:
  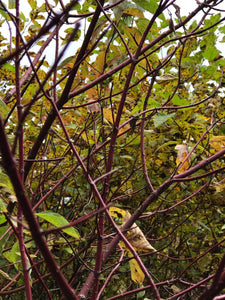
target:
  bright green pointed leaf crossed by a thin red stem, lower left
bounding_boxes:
[36,211,80,239]
